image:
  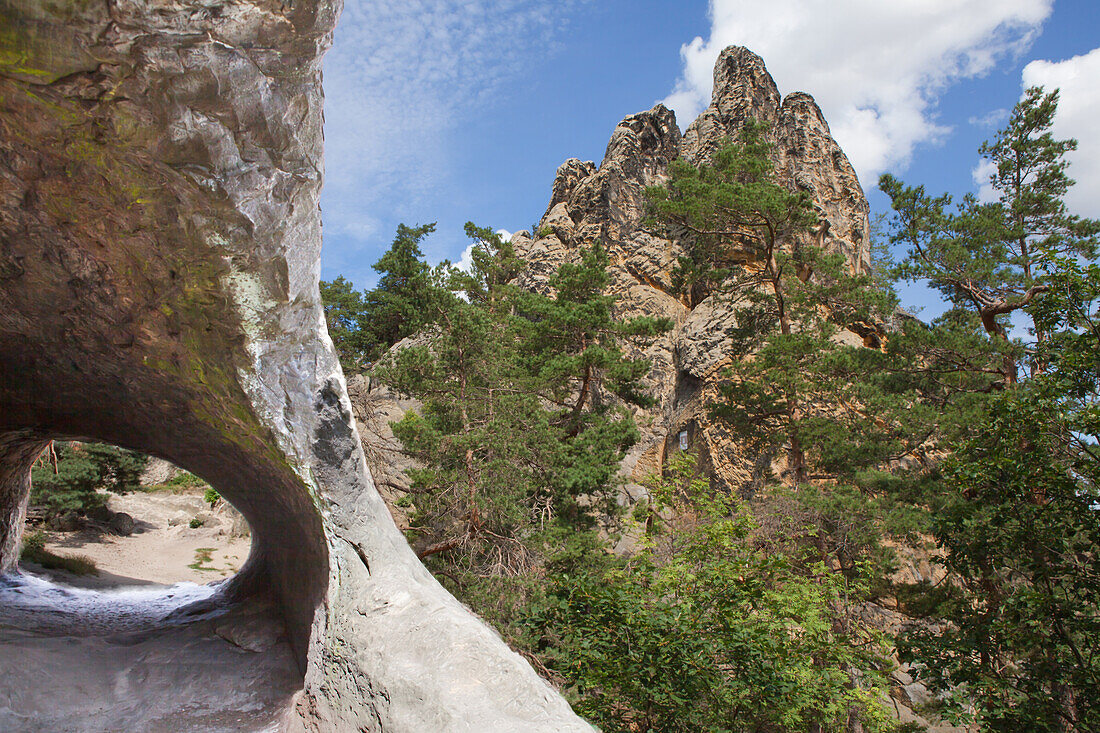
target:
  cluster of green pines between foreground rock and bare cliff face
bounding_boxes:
[375,231,667,584]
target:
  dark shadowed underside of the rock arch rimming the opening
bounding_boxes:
[0,392,328,674]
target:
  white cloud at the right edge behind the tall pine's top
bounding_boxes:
[1023,48,1100,218]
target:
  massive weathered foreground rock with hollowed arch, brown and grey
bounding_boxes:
[0,0,594,732]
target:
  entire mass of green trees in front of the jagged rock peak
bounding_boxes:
[312,89,1100,732]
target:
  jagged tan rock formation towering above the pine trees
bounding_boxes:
[513,46,868,495]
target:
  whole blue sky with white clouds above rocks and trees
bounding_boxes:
[321,0,1100,309]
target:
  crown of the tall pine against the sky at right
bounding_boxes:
[879,87,1100,386]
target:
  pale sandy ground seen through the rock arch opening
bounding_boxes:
[30,490,251,588]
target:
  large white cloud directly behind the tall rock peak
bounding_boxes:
[666,0,1053,185]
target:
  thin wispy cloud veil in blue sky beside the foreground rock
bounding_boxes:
[323,0,581,240]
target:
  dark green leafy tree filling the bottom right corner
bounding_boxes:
[899,394,1100,733]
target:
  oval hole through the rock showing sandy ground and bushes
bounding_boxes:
[19,441,251,590]
